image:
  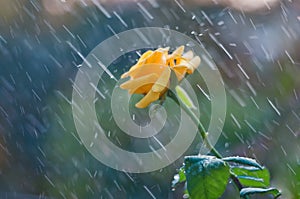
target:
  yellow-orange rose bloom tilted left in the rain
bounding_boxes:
[120,46,200,108]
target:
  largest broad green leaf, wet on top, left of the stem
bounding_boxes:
[185,156,230,199]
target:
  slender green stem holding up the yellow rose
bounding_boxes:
[168,92,248,199]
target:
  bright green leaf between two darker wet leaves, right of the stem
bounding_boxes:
[230,167,270,188]
